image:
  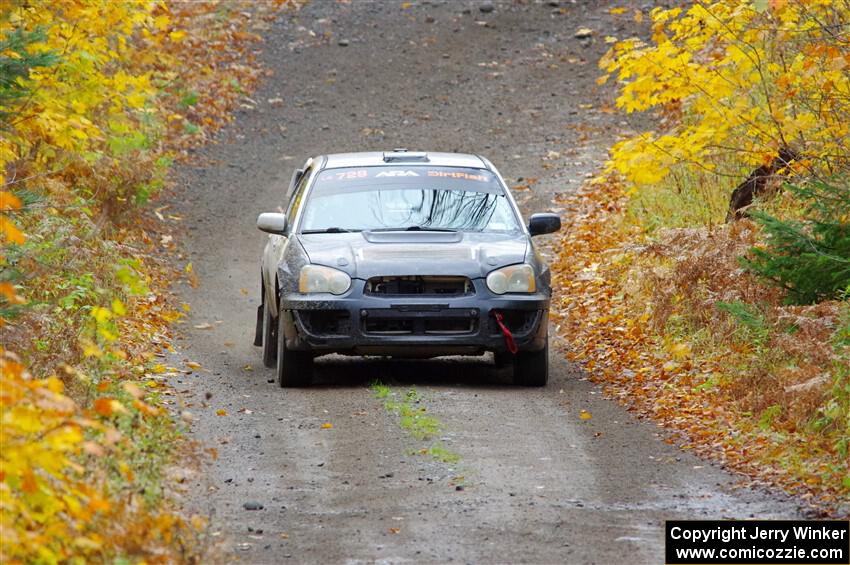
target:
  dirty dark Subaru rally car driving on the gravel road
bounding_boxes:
[254,150,561,387]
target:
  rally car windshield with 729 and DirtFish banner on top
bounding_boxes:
[301,166,521,233]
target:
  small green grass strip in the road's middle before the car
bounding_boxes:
[370,382,460,464]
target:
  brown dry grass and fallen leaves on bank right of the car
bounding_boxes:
[553,177,850,514]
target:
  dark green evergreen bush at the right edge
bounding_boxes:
[742,181,850,304]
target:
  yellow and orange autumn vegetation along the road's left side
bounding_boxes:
[0,0,284,563]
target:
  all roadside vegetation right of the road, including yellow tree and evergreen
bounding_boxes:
[556,0,850,514]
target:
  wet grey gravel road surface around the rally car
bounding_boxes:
[173,0,798,563]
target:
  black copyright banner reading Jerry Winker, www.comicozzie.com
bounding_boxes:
[664,520,850,565]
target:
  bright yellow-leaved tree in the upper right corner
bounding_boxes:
[600,0,850,198]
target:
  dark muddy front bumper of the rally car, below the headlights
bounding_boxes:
[274,279,549,356]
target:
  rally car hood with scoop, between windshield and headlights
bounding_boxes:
[299,231,528,280]
